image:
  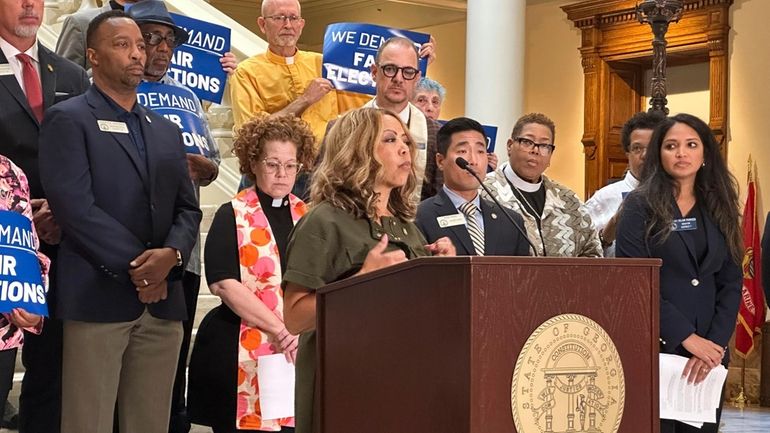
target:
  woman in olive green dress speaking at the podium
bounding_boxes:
[283,108,455,433]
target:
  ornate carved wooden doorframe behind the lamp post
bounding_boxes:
[562,0,733,197]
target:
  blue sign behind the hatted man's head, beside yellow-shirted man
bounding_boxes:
[168,14,230,104]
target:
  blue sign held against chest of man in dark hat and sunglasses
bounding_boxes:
[136,81,211,156]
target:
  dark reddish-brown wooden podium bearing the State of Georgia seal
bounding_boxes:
[316,257,660,433]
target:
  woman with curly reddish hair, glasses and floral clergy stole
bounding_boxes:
[188,116,314,433]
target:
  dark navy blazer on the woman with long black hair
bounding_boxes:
[616,192,743,362]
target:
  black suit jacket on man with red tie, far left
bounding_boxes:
[0,43,90,198]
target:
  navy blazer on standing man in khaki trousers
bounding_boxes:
[40,87,201,322]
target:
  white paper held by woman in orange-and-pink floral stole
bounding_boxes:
[257,353,294,419]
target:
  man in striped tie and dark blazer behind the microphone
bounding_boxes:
[415,117,529,256]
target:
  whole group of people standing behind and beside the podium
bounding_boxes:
[0,0,743,433]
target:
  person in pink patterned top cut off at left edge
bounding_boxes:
[0,155,51,424]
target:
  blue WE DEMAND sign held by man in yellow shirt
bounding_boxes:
[323,23,430,95]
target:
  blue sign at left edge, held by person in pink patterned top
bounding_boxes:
[0,210,48,316]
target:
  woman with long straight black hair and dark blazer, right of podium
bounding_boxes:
[617,114,743,433]
